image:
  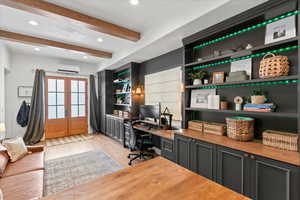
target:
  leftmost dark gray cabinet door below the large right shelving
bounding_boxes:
[174,134,192,169]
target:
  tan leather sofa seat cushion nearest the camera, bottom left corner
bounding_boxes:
[0,170,44,200]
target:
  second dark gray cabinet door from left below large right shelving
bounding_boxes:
[191,140,216,180]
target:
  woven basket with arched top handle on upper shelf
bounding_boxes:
[259,53,290,78]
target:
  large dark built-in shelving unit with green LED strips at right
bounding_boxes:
[182,1,300,149]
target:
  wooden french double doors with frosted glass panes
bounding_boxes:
[45,76,88,139]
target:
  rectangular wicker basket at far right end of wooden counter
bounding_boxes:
[263,130,298,151]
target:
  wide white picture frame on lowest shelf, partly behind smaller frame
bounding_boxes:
[190,89,216,108]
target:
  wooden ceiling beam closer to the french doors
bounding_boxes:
[0,29,112,58]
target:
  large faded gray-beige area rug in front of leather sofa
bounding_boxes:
[44,150,122,196]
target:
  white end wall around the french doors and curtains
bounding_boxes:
[5,52,97,137]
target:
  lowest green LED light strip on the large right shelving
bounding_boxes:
[198,79,298,89]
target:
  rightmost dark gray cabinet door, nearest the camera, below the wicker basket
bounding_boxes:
[251,155,300,200]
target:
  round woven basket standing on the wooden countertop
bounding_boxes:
[226,117,254,141]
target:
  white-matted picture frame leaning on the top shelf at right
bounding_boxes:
[265,16,296,44]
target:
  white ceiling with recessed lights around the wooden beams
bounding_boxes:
[0,0,266,70]
